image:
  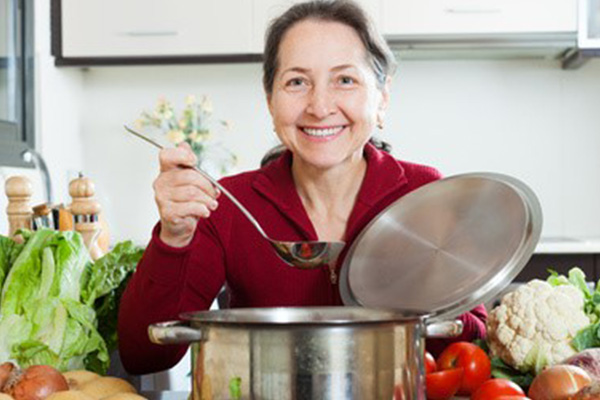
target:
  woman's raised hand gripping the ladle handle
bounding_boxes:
[153,142,219,247]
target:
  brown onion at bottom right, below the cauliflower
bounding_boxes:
[527,365,592,400]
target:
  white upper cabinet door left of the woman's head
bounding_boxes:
[61,0,252,57]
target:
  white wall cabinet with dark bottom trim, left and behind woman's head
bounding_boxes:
[51,0,381,65]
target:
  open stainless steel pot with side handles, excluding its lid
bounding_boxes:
[149,307,462,400]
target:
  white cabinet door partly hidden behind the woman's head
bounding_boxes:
[252,0,381,54]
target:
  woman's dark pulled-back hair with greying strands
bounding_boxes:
[261,0,396,166]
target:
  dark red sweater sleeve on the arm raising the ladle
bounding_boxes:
[118,221,225,374]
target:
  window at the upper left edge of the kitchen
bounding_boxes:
[0,0,34,167]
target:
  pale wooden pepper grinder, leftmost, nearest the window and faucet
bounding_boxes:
[4,176,33,237]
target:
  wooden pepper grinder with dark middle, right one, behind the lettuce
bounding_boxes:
[69,174,104,261]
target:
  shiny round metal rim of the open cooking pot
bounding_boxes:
[180,306,426,328]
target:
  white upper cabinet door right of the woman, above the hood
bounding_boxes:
[382,0,577,36]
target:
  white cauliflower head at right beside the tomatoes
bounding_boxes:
[487,279,590,373]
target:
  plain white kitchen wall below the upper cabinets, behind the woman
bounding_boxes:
[75,60,600,242]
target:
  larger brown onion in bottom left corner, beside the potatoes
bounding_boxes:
[4,365,69,400]
